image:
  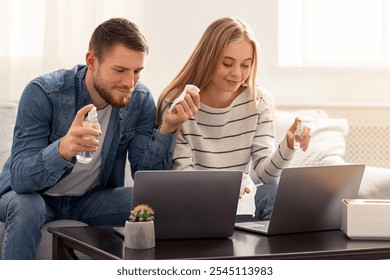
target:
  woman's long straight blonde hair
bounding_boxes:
[157,17,258,125]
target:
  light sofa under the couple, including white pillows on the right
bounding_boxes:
[0,102,390,259]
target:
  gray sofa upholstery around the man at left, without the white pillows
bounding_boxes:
[0,102,86,259]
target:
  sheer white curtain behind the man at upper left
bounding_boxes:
[0,0,143,101]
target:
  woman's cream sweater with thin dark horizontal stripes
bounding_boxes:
[172,86,294,183]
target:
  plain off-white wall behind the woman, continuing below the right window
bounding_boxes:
[0,0,390,107]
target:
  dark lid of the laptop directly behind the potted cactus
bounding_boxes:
[132,170,242,239]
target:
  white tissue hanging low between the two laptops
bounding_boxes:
[237,173,257,217]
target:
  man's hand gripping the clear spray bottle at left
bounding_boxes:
[58,104,101,161]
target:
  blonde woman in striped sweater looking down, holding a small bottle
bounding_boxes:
[157,17,310,220]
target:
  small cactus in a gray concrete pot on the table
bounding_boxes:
[125,204,155,249]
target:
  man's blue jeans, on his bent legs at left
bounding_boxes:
[0,187,133,260]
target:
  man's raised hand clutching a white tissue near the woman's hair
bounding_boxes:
[160,90,200,134]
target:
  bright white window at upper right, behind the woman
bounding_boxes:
[278,0,390,67]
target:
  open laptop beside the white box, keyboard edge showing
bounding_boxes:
[235,164,365,235]
